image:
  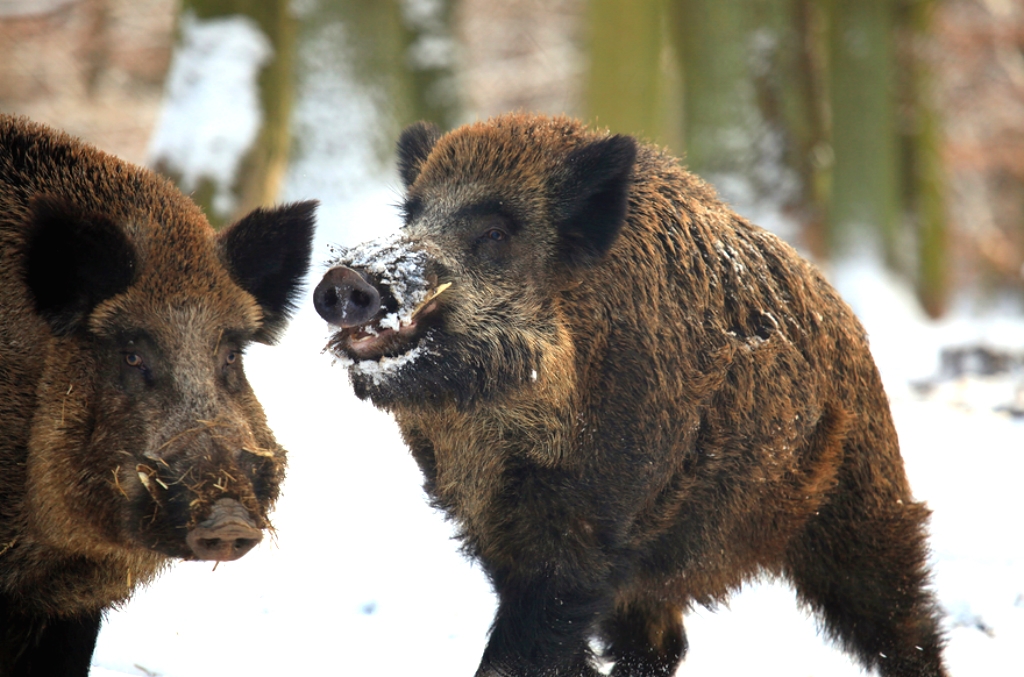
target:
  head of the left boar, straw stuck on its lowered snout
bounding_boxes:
[24,197,315,560]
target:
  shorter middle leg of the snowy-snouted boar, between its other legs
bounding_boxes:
[601,602,687,677]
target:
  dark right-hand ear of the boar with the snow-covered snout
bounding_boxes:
[554,134,637,265]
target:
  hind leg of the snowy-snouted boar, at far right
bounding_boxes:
[786,483,946,677]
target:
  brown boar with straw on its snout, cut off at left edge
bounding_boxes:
[0,116,315,677]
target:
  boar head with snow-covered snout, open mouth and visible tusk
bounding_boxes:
[313,116,636,409]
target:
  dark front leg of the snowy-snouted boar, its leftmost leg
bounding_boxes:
[476,574,606,677]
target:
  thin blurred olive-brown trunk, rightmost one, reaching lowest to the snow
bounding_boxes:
[899,0,951,318]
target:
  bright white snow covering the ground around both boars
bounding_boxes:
[92,11,1024,677]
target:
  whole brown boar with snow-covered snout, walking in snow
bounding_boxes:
[313,115,944,677]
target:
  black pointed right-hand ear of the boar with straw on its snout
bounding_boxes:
[217,201,318,343]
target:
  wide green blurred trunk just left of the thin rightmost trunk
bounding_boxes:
[829,0,899,256]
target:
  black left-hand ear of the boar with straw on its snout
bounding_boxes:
[25,197,135,336]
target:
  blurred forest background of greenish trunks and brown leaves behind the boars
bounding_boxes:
[0,0,1024,318]
